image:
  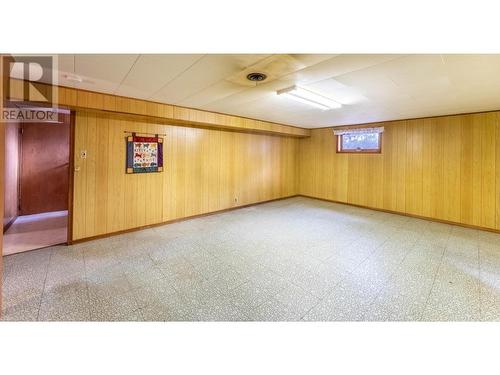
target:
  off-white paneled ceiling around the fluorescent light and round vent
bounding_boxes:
[24,54,500,128]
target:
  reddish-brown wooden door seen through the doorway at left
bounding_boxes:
[19,116,70,215]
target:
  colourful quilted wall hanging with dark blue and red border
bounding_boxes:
[127,133,163,173]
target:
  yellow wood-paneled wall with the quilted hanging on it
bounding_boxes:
[73,111,299,240]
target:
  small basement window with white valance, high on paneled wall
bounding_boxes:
[333,127,384,154]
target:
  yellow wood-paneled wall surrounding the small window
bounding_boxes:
[299,112,500,230]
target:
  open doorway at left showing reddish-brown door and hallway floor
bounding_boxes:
[3,110,72,255]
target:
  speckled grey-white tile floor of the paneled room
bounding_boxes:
[3,198,500,321]
